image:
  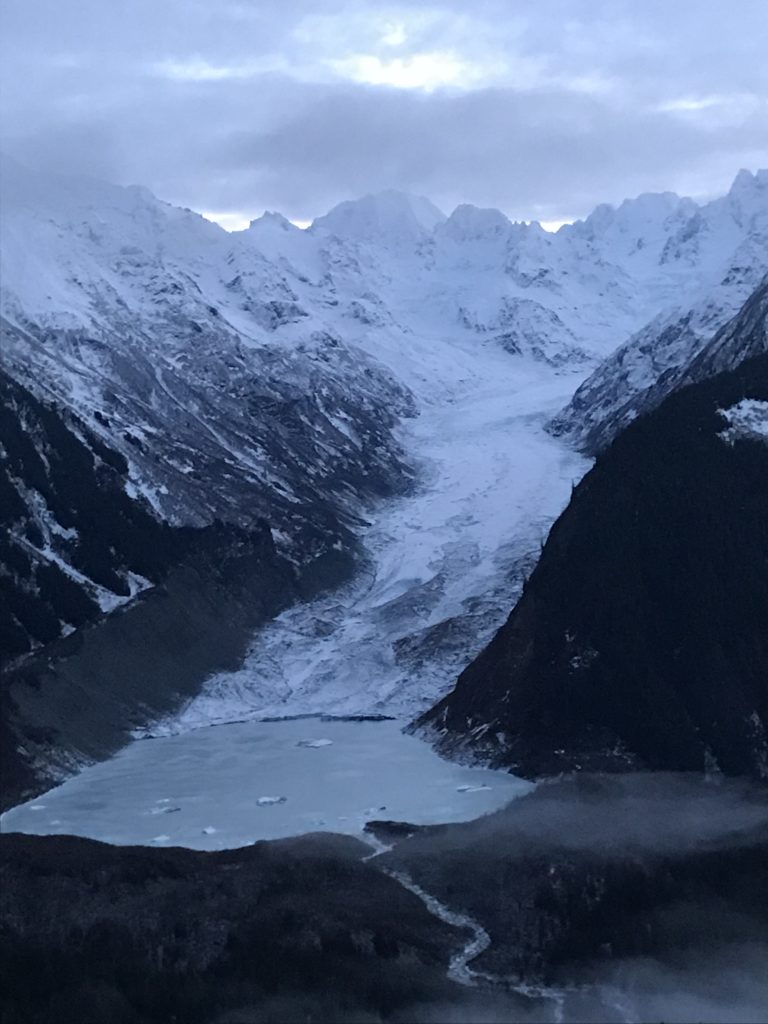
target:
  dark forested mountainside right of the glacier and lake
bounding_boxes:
[418,348,768,778]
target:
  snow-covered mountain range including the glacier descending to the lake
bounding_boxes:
[0,161,768,782]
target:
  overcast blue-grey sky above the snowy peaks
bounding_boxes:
[0,0,768,223]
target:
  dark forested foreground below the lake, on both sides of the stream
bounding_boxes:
[6,773,768,1024]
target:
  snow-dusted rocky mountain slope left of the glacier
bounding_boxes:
[2,156,421,556]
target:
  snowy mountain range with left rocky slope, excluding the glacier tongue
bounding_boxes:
[0,160,768,491]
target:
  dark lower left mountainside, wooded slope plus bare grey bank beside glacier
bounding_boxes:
[0,372,354,807]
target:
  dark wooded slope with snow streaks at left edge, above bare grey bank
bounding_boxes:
[0,371,199,667]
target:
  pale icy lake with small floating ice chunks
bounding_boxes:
[0,718,531,850]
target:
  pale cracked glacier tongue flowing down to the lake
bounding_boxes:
[153,348,589,735]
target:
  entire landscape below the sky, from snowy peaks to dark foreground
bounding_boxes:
[0,159,768,1024]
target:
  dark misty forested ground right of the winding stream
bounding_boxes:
[382,772,768,983]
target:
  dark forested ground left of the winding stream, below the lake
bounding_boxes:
[0,835,464,1024]
